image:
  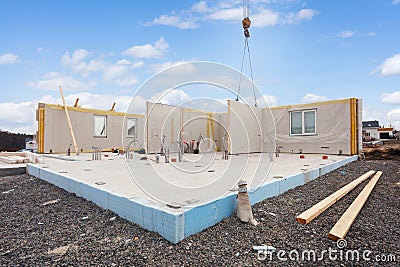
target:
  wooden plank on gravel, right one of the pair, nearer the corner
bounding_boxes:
[328,171,382,241]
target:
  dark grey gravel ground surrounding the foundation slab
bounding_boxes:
[0,161,400,266]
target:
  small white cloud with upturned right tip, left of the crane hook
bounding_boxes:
[122,37,168,58]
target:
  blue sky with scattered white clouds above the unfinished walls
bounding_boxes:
[0,0,400,133]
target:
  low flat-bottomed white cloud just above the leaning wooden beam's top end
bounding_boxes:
[26,72,96,91]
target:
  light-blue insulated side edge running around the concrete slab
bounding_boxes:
[26,156,358,244]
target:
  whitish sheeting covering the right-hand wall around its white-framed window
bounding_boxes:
[263,99,362,155]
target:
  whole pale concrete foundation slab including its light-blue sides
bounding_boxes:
[27,153,357,243]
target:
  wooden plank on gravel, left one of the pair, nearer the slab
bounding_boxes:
[296,171,375,224]
